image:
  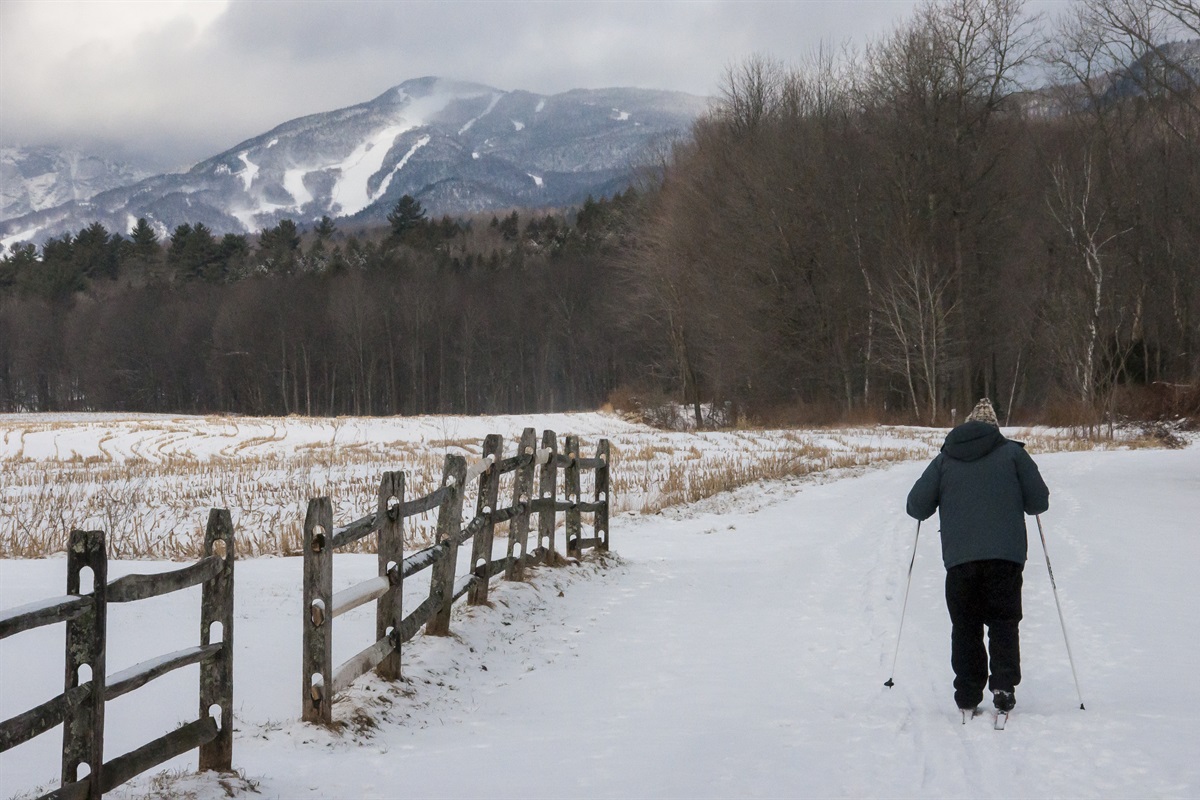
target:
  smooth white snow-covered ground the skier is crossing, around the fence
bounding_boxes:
[0,422,1200,800]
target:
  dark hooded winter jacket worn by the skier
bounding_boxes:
[908,421,1050,570]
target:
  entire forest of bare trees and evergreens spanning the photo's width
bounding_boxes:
[0,0,1200,425]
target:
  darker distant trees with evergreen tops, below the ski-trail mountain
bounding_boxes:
[0,191,637,415]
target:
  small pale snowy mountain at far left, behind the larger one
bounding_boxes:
[0,145,150,219]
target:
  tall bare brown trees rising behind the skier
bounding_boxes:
[625,0,1200,423]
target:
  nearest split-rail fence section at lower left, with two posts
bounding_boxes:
[0,509,234,800]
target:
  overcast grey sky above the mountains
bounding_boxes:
[0,0,1070,168]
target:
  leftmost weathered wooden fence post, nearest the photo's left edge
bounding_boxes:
[61,530,108,798]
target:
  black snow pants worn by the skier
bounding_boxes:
[946,559,1025,709]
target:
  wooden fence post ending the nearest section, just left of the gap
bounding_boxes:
[199,509,234,772]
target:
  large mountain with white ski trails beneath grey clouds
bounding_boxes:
[0,78,707,243]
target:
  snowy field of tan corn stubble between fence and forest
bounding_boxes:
[0,413,1129,560]
